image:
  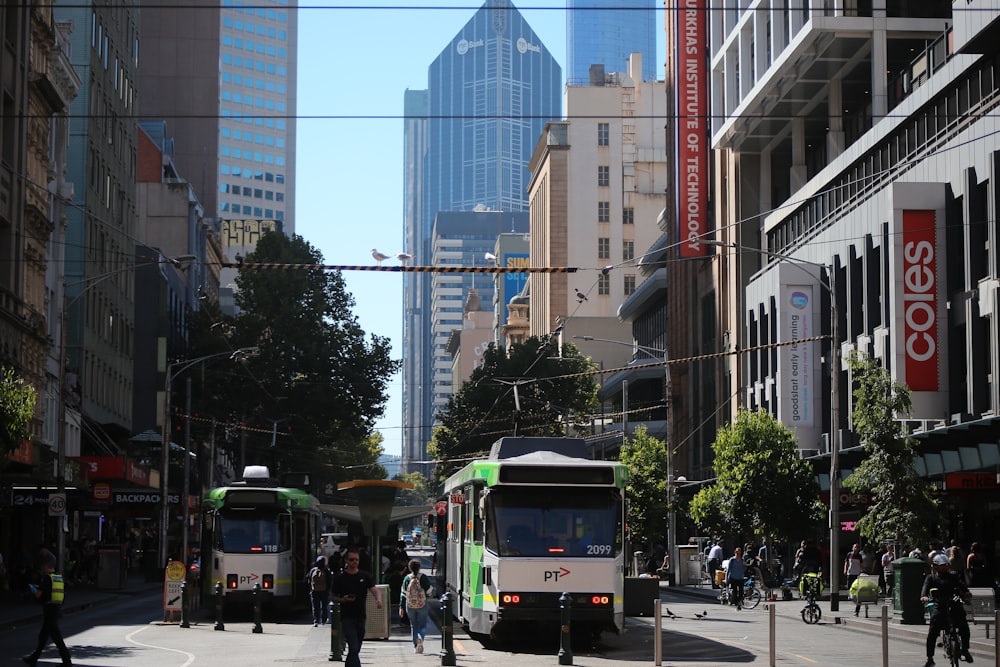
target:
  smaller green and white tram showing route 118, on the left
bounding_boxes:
[201,466,322,608]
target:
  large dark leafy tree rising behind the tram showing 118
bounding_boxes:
[186,233,399,484]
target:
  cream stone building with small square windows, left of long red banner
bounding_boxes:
[528,53,668,368]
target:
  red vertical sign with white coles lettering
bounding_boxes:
[902,210,941,391]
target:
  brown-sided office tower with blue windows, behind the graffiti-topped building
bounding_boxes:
[139,0,298,235]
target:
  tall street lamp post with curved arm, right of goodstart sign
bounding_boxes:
[702,240,841,611]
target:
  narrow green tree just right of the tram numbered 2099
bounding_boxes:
[618,426,669,545]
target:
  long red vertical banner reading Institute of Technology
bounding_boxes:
[675,0,710,257]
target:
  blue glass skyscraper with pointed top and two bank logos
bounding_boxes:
[403,0,562,470]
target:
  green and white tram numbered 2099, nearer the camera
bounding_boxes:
[438,437,627,638]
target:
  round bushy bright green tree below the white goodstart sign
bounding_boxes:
[691,410,824,541]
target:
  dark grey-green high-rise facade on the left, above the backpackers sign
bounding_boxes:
[55,1,140,447]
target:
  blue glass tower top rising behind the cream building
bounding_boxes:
[566,0,663,85]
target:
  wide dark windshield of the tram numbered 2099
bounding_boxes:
[485,487,622,558]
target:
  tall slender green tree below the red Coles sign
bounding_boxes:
[844,352,942,544]
